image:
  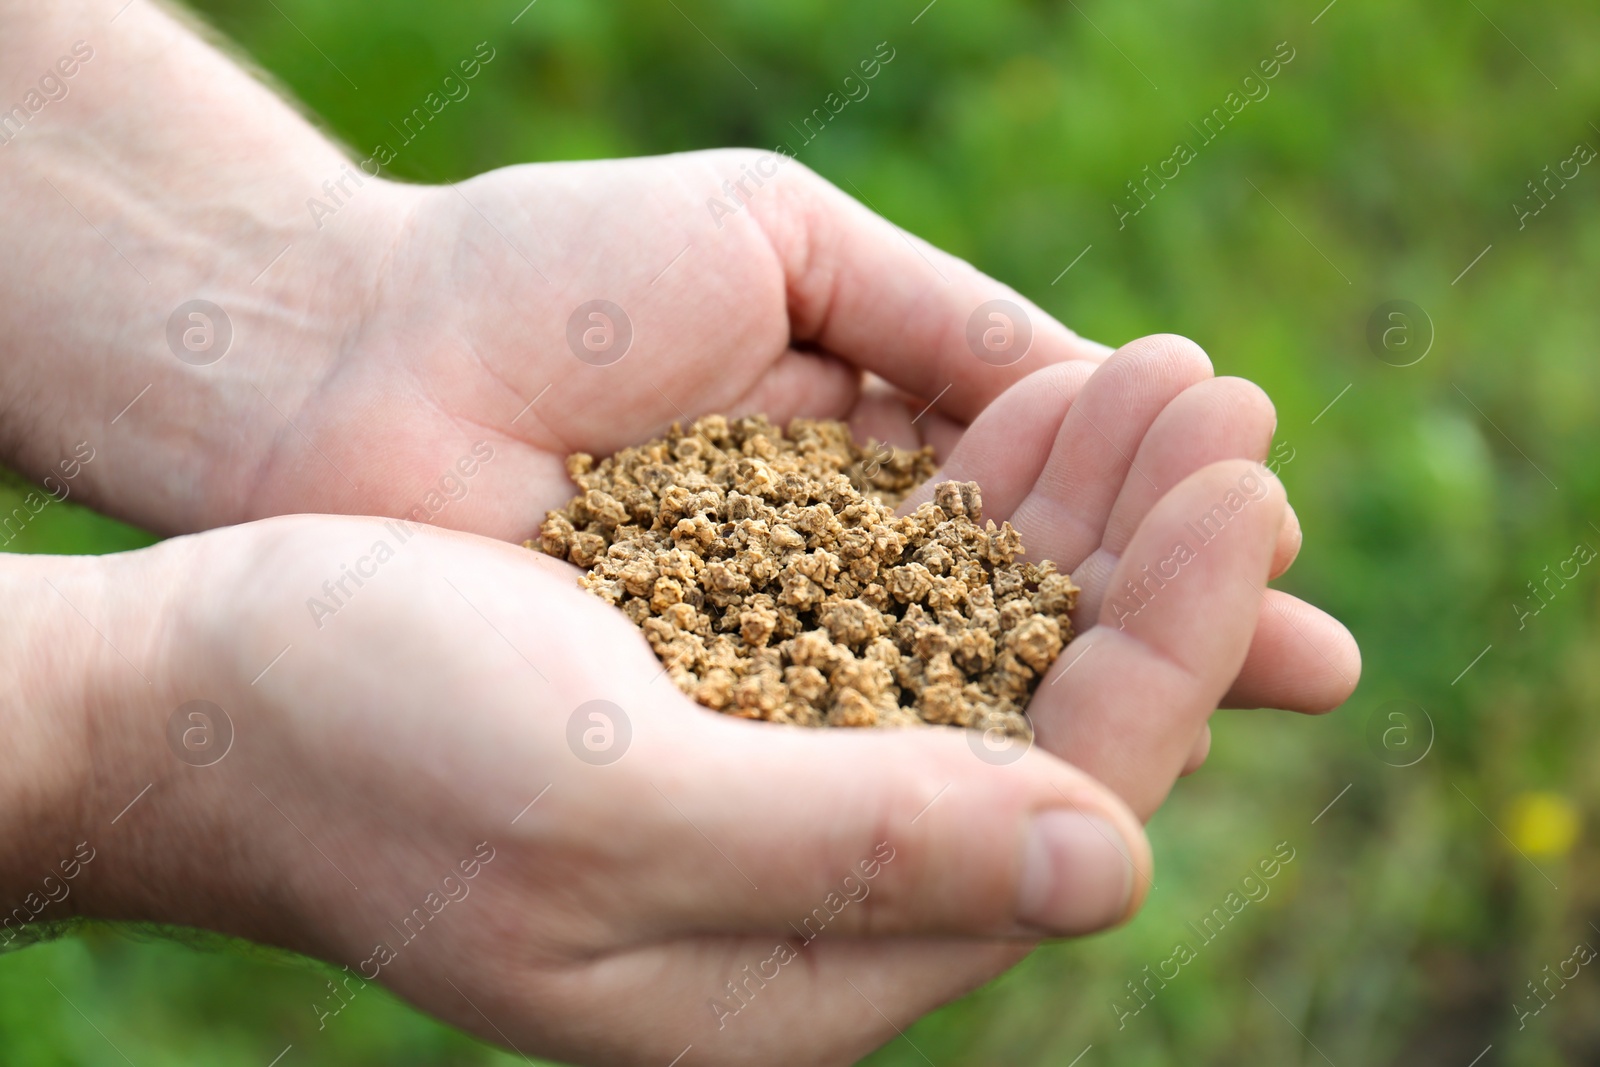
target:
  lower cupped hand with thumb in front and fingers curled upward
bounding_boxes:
[3,339,1355,1064]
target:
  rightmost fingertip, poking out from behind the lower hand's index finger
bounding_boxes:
[1222,589,1362,713]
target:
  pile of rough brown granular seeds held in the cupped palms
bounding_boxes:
[526,416,1078,737]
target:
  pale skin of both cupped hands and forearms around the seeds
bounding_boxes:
[0,0,1360,1064]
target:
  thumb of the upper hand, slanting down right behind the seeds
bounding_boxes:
[728,154,1109,422]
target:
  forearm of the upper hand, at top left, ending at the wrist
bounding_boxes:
[0,0,406,531]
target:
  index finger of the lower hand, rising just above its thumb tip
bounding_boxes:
[1029,459,1285,817]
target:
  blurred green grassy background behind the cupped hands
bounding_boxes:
[0,0,1600,1067]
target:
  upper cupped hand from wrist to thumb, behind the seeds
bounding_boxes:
[236,150,1109,541]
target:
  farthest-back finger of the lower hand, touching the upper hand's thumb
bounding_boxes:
[901,360,1096,520]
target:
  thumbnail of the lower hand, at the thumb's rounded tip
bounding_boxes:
[1018,808,1133,936]
